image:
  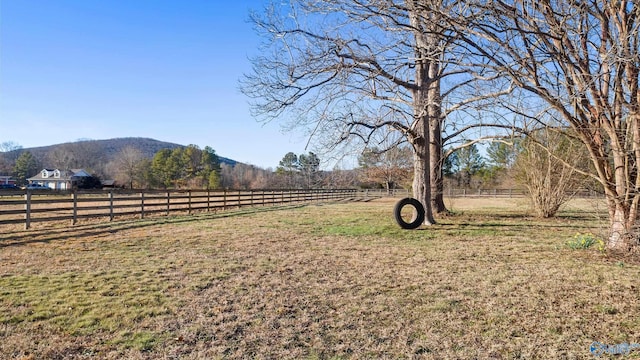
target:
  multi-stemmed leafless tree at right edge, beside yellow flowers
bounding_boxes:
[458,0,640,249]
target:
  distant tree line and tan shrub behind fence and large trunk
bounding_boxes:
[0,135,597,217]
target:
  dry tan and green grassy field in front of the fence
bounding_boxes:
[0,199,640,359]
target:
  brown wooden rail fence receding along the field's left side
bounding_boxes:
[0,189,368,229]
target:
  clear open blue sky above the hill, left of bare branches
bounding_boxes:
[0,0,312,168]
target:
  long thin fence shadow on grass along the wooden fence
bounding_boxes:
[0,204,308,249]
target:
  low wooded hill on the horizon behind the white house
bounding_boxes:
[2,137,237,176]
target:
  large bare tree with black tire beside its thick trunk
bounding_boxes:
[241,0,510,223]
